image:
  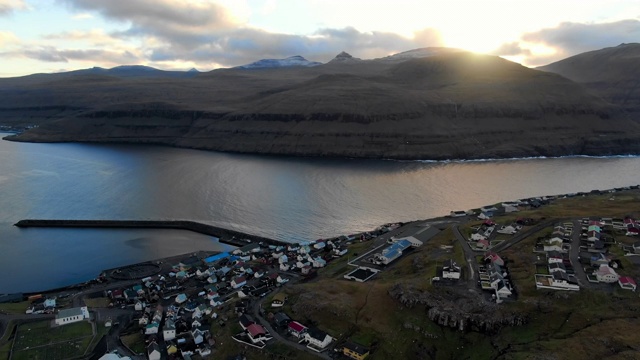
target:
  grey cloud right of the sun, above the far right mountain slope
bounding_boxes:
[492,19,640,66]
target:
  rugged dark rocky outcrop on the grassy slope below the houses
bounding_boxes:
[389,284,527,332]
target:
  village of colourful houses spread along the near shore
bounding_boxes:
[0,189,640,360]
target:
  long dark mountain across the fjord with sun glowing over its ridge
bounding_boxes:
[0,48,640,159]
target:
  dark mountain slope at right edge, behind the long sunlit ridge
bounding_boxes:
[538,43,640,112]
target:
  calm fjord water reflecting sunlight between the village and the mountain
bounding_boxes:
[0,135,640,293]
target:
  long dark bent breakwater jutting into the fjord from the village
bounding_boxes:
[14,219,292,247]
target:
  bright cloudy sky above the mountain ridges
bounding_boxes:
[0,0,640,77]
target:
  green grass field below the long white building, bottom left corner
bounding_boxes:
[12,320,93,360]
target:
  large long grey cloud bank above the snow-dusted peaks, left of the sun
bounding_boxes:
[59,0,442,67]
